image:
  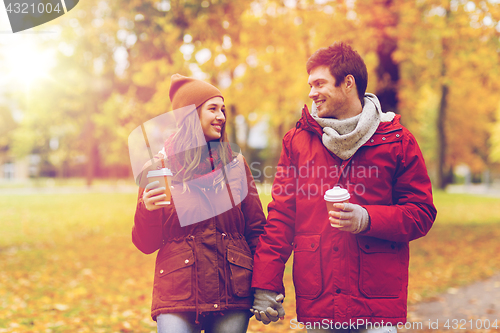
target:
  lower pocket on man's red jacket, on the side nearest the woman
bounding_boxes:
[293,235,323,299]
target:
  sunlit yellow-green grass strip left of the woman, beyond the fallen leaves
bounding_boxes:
[0,193,136,248]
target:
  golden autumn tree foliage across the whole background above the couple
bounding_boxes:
[7,0,499,187]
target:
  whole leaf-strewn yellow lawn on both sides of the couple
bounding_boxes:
[0,188,500,333]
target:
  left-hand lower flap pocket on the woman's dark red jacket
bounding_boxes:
[155,250,194,301]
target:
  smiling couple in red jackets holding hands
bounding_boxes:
[132,43,436,333]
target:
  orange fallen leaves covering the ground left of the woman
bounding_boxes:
[0,236,156,332]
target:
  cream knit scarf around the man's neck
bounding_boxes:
[311,93,395,160]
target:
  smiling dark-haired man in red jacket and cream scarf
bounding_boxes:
[252,43,436,333]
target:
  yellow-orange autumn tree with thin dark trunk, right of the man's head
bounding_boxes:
[396,0,499,188]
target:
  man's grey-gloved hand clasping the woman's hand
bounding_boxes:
[250,288,285,325]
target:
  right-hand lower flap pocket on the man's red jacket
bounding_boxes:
[357,236,405,298]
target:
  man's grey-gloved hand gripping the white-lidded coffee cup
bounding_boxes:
[328,203,370,234]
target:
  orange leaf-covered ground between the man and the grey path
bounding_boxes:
[408,223,500,304]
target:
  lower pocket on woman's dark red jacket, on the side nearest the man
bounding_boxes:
[226,246,253,297]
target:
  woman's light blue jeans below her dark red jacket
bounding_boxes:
[156,310,251,333]
